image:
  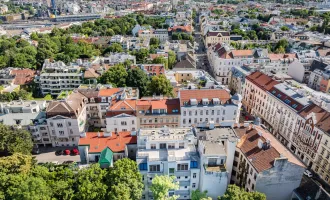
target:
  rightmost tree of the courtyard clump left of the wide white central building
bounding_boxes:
[148,75,173,96]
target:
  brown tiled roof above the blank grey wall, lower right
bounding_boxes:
[234,125,305,172]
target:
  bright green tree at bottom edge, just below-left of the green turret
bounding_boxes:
[75,164,108,200]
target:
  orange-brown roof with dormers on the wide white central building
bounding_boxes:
[179,89,230,106]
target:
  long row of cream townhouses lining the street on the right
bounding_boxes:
[242,72,330,183]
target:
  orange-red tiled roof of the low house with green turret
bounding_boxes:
[79,132,137,153]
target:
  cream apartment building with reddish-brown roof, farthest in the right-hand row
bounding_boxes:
[242,71,279,117]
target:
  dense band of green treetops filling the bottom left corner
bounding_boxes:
[0,153,143,200]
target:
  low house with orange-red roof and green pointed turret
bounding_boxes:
[78,132,136,165]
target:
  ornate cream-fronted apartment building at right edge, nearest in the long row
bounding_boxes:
[290,104,330,183]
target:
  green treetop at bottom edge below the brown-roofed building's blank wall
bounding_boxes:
[218,185,266,200]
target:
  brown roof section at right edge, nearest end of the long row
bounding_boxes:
[299,104,330,134]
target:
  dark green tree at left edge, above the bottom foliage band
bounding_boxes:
[0,124,33,155]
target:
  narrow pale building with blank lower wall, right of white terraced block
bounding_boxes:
[198,125,238,199]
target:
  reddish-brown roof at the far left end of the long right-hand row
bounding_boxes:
[246,71,279,91]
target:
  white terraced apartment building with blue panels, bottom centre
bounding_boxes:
[136,127,201,199]
